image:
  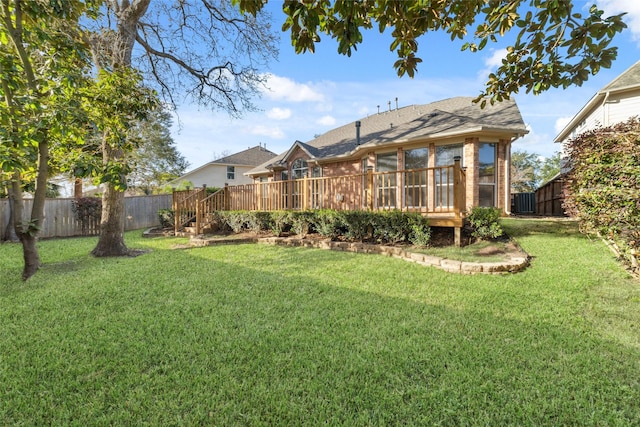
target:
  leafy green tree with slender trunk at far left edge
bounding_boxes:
[0,0,92,280]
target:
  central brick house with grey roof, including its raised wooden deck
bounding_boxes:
[174,97,527,242]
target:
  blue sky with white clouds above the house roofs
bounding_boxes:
[171,0,640,170]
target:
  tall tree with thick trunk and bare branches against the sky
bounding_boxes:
[88,0,276,256]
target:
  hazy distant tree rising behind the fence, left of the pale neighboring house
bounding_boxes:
[128,109,189,194]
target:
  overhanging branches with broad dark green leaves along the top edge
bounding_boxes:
[238,0,626,105]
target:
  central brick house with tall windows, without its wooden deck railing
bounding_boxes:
[247,97,527,214]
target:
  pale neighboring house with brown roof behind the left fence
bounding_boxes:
[172,145,276,188]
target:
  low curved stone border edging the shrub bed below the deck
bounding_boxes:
[191,237,529,274]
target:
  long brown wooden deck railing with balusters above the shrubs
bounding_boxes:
[174,161,466,233]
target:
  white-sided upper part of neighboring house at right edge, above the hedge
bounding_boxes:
[554,61,640,154]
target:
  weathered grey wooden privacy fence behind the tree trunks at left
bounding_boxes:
[0,194,172,240]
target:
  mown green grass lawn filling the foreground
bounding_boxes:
[0,220,640,426]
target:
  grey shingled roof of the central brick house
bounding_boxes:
[247,97,527,175]
